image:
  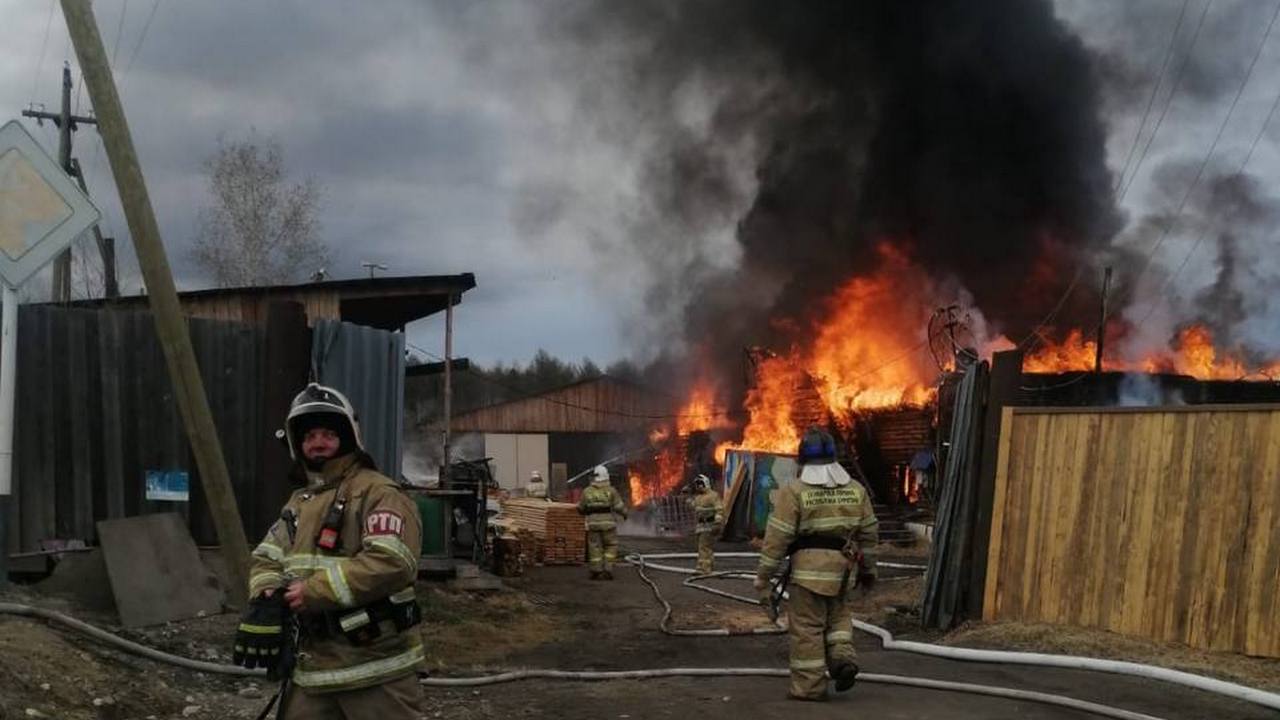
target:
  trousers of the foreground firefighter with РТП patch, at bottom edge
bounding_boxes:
[284,673,426,720]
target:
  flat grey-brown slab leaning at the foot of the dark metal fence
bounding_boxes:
[97,512,224,628]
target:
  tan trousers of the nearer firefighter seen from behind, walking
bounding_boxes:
[787,583,858,700]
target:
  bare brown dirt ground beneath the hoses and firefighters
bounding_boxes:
[0,539,1280,720]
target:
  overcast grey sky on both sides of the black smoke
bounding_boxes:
[0,0,1280,364]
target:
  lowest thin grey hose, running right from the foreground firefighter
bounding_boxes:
[421,667,1162,720]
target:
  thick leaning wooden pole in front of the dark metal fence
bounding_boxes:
[61,0,248,607]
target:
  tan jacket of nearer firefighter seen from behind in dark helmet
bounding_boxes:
[758,465,879,597]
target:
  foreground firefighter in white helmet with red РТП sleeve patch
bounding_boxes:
[234,383,425,720]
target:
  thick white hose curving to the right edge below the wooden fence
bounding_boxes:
[628,552,1280,710]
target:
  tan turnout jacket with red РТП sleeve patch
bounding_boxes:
[250,454,424,692]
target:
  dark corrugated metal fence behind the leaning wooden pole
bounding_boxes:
[9,305,285,551]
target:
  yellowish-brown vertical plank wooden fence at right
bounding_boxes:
[983,405,1280,657]
